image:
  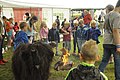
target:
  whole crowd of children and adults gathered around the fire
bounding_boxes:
[0,0,120,80]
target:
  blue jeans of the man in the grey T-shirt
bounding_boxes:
[99,44,120,80]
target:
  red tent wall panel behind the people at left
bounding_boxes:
[13,8,42,22]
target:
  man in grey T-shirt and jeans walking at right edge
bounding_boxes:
[99,0,120,80]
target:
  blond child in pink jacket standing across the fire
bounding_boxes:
[40,21,49,44]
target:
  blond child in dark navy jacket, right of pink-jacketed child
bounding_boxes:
[48,22,60,56]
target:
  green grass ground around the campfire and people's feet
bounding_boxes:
[0,37,114,80]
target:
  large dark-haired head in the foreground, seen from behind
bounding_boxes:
[12,42,54,80]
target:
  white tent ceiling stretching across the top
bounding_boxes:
[0,0,118,8]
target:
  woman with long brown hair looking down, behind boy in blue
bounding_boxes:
[26,16,38,43]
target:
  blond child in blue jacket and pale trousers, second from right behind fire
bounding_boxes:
[76,19,88,53]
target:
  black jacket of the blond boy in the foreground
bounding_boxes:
[65,65,105,80]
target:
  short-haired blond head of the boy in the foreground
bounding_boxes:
[80,39,99,62]
